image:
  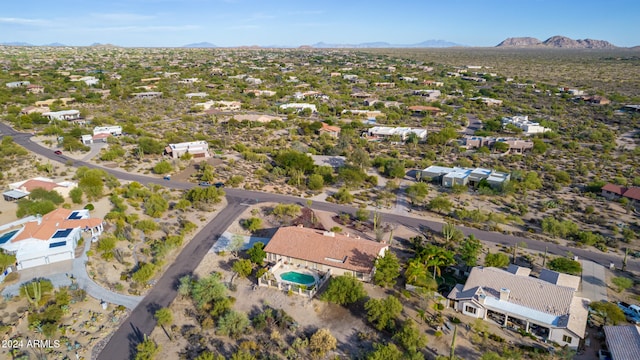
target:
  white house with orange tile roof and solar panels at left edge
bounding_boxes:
[0,208,104,270]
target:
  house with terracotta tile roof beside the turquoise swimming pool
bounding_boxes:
[264,226,389,281]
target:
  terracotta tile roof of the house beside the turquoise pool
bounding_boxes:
[264,226,389,273]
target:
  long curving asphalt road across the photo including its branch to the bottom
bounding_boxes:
[0,123,640,360]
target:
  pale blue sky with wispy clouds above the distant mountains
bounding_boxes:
[0,0,640,46]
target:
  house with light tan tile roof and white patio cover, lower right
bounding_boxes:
[447,266,589,349]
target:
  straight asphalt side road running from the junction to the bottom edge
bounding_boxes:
[98,202,246,360]
